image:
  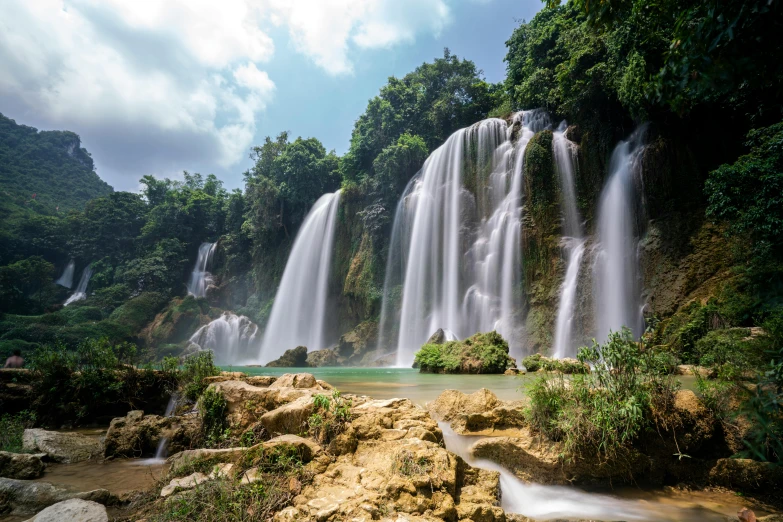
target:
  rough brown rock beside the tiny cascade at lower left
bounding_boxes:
[103,410,200,458]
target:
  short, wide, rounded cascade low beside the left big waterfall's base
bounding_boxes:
[188,312,258,364]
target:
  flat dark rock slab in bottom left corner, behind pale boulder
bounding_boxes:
[0,478,116,516]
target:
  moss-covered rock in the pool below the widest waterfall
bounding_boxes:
[414,332,516,373]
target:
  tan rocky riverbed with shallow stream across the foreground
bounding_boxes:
[0,373,783,522]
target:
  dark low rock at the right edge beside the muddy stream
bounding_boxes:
[709,459,783,494]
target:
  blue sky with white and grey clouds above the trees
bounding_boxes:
[0,0,542,190]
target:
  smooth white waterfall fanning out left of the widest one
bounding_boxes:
[259,190,340,363]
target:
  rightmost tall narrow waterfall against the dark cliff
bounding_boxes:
[593,128,644,342]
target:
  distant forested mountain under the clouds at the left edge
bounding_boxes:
[0,114,113,215]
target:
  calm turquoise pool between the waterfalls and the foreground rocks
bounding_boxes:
[223,366,693,406]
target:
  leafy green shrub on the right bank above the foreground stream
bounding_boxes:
[527,328,677,471]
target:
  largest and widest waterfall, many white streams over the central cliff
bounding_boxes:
[386,111,549,366]
